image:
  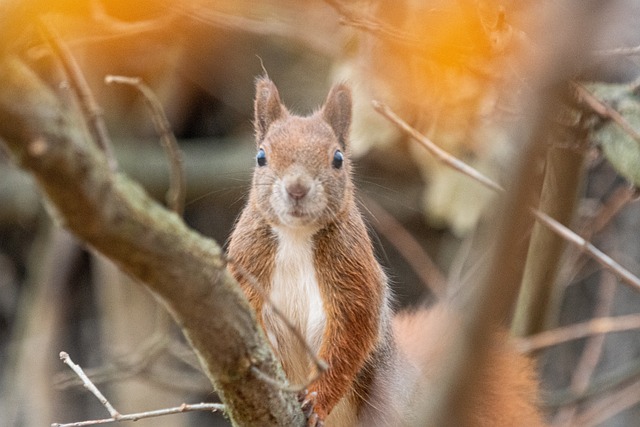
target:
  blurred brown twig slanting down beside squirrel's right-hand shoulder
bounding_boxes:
[360,195,447,298]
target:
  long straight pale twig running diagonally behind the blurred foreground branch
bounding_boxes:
[372,101,640,296]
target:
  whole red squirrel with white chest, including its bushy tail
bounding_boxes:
[228,77,542,427]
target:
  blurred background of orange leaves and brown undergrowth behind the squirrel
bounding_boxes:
[0,0,640,427]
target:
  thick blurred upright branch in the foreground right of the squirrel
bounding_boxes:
[374,2,598,425]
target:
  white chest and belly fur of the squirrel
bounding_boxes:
[263,227,325,384]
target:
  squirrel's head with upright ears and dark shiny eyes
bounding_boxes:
[252,77,353,229]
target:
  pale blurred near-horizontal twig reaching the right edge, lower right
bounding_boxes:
[516,314,640,353]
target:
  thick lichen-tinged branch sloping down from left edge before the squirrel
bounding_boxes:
[0,58,302,426]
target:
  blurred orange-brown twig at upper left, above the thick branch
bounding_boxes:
[39,20,118,171]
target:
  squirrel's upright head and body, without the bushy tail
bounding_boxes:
[229,79,393,425]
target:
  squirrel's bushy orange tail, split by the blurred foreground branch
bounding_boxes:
[384,303,545,427]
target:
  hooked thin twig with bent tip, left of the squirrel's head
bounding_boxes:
[105,75,187,215]
